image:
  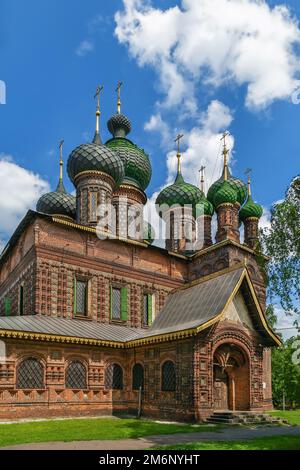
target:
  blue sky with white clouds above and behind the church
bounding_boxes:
[0,0,300,334]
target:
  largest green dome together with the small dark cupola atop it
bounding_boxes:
[105,114,152,191]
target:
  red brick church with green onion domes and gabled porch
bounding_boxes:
[0,90,280,420]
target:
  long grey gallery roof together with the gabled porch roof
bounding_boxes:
[0,267,281,347]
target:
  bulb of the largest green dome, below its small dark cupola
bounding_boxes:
[106,137,152,191]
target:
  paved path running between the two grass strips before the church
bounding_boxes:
[1,426,300,450]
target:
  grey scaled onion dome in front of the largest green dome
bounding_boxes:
[68,142,124,186]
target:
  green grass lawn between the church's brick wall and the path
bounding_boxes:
[0,418,220,447]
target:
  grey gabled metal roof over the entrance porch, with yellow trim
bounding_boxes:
[141,267,281,346]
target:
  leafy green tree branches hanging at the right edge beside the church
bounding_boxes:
[261,176,300,313]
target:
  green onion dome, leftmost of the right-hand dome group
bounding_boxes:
[156,173,203,215]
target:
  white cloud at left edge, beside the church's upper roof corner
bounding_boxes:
[0,154,50,250]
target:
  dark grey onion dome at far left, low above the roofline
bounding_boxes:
[36,180,76,219]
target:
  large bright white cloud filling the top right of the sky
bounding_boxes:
[115,0,300,113]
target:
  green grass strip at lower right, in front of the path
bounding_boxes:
[151,436,300,450]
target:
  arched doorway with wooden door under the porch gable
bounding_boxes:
[213,343,250,411]
